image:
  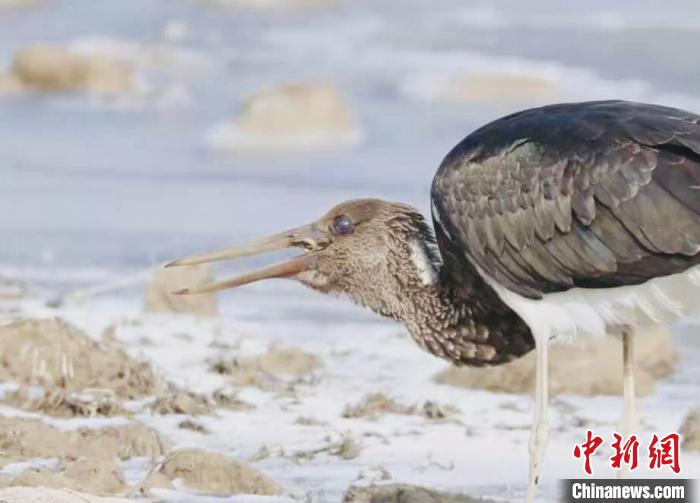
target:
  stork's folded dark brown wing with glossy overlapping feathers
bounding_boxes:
[432,101,700,298]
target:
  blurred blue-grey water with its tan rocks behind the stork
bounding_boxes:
[0,0,700,278]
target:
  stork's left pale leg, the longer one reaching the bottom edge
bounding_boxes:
[526,337,549,503]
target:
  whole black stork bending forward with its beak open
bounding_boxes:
[169,101,700,502]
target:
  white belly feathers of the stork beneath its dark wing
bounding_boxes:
[478,266,700,340]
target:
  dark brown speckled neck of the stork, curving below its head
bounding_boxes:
[394,232,534,366]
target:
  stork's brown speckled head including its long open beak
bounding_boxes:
[168,199,439,317]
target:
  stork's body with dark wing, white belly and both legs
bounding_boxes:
[433,102,700,501]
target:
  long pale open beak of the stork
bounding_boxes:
[165,222,330,295]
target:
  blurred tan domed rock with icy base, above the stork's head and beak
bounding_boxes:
[207,82,359,150]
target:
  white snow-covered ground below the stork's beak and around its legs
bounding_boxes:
[0,274,700,502]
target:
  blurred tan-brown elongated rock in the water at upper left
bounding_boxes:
[12,44,133,96]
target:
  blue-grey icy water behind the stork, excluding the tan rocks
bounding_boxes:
[0,0,700,267]
